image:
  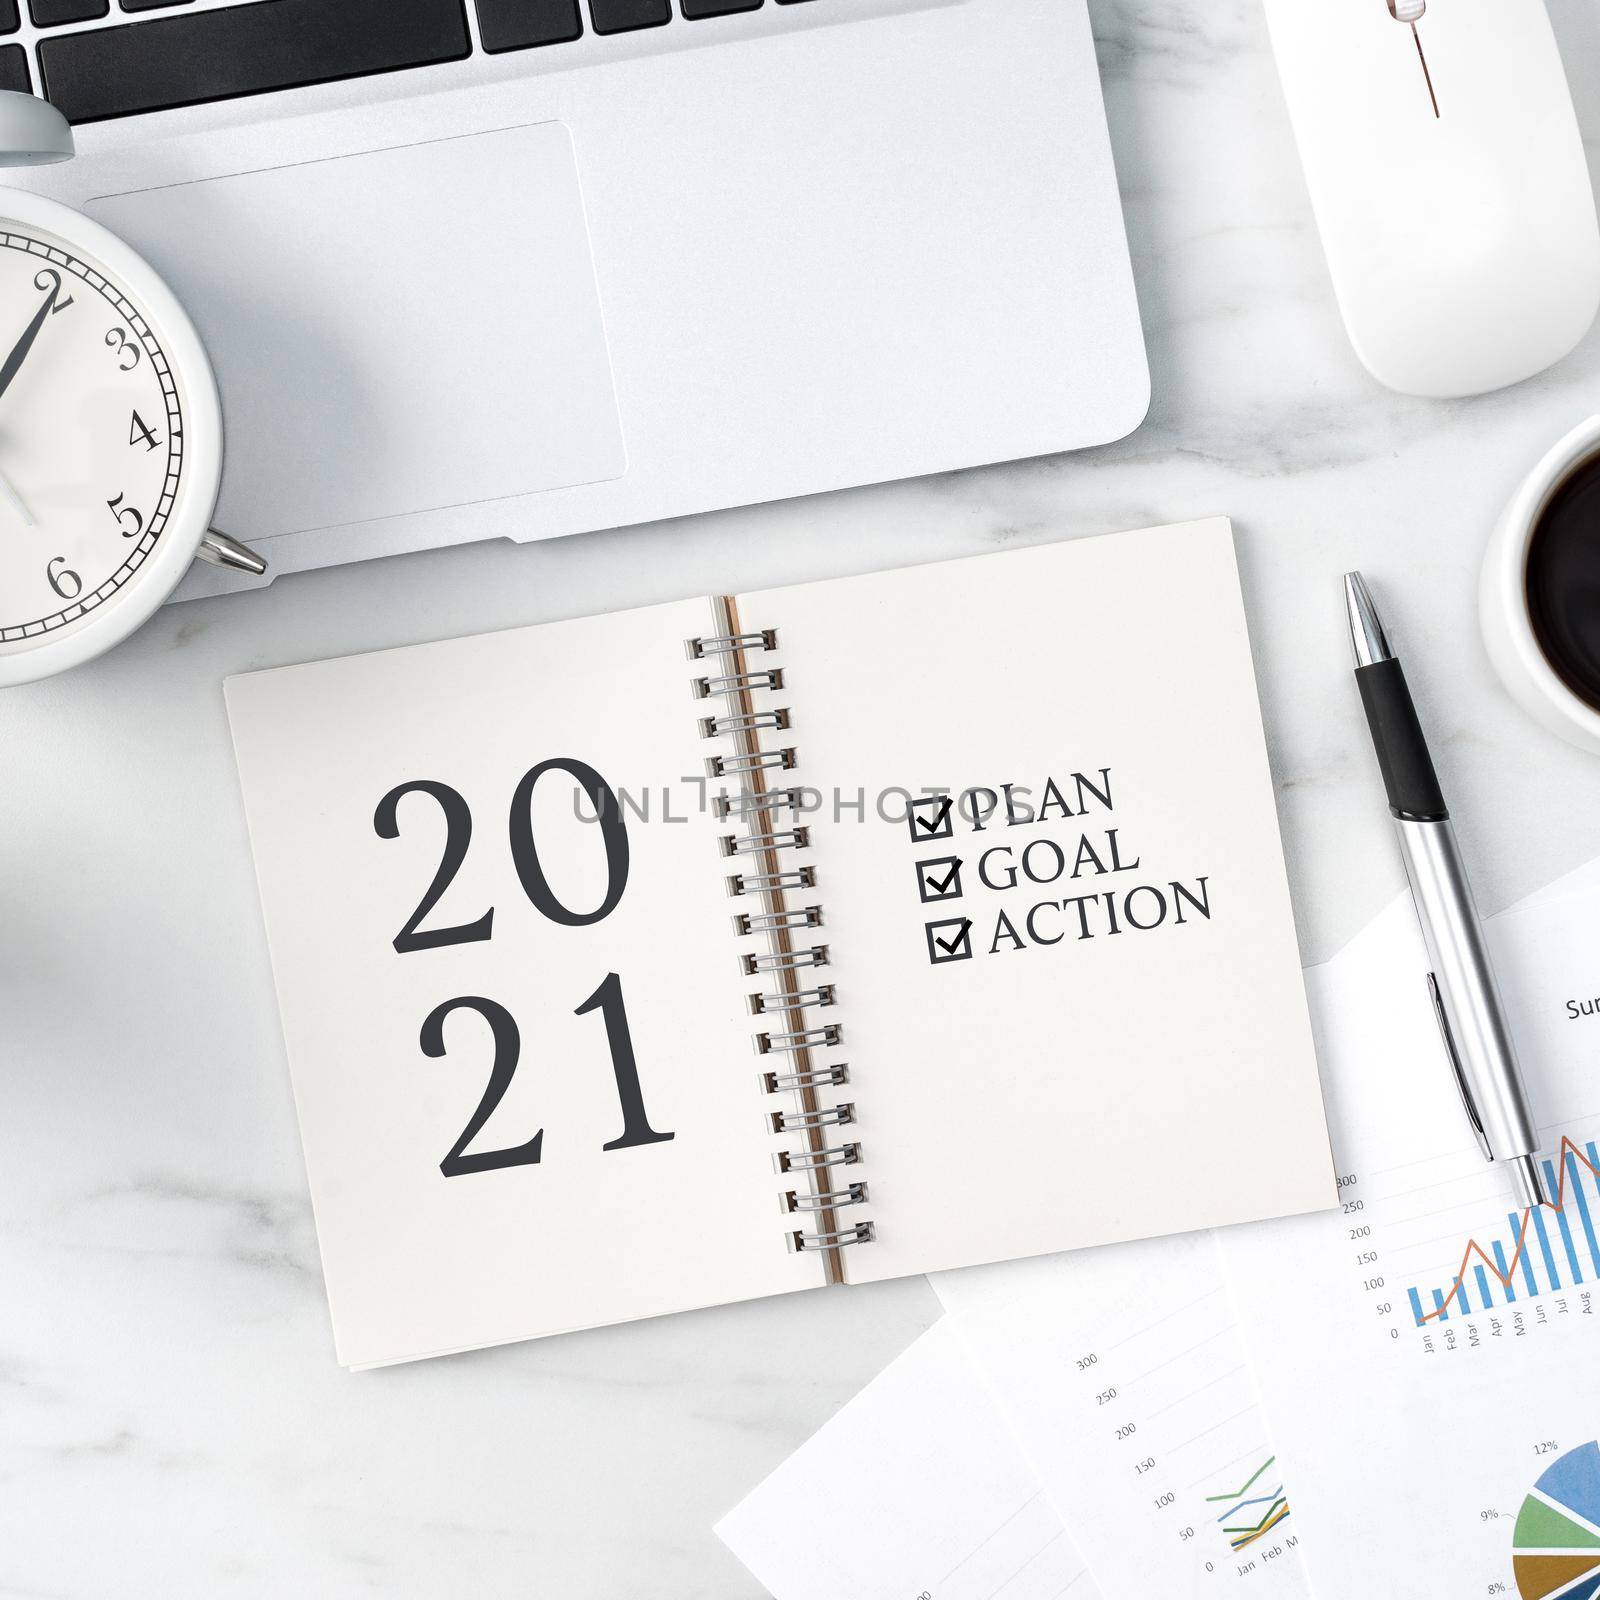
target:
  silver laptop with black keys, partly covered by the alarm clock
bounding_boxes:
[0,0,1149,594]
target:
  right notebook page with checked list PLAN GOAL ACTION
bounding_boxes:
[741,520,1334,1282]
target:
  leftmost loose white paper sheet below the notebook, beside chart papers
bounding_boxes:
[717,1318,1099,1600]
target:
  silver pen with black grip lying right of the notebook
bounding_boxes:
[1344,573,1550,1206]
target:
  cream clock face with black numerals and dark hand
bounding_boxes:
[0,218,184,654]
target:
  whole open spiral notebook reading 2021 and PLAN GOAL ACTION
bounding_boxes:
[227,520,1334,1366]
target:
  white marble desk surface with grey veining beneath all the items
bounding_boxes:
[0,0,1600,1600]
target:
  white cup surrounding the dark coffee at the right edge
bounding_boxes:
[1478,416,1600,755]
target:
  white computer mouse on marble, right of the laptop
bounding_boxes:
[1266,0,1600,398]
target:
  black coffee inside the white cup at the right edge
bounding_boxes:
[1526,444,1600,710]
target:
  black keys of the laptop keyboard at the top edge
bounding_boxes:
[0,0,827,123]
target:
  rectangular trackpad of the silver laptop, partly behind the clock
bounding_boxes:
[86,122,627,539]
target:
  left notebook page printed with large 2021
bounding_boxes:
[227,600,821,1366]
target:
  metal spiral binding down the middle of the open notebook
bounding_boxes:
[688,598,872,1282]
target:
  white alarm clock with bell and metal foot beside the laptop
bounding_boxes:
[0,93,266,686]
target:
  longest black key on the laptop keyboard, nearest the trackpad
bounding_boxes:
[38,0,472,122]
